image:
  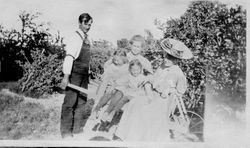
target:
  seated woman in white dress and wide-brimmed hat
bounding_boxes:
[115,38,192,142]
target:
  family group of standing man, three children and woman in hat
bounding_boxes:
[61,13,193,141]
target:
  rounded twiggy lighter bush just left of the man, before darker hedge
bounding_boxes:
[18,50,62,97]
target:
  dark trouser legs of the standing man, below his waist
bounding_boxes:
[61,73,89,137]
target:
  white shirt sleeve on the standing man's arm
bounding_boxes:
[63,30,82,74]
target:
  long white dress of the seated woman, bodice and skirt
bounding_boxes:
[116,65,186,142]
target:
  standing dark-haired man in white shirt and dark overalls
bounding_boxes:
[60,13,93,138]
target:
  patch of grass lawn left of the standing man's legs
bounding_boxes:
[0,90,61,140]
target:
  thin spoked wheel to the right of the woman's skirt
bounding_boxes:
[187,111,204,141]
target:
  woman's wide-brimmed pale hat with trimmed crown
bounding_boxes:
[160,38,193,59]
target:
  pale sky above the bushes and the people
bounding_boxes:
[0,0,246,45]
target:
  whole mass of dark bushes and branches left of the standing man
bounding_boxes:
[0,11,65,97]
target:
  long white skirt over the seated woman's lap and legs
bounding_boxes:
[117,95,169,141]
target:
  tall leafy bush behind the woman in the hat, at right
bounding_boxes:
[152,1,246,113]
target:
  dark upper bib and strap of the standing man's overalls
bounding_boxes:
[72,31,90,74]
